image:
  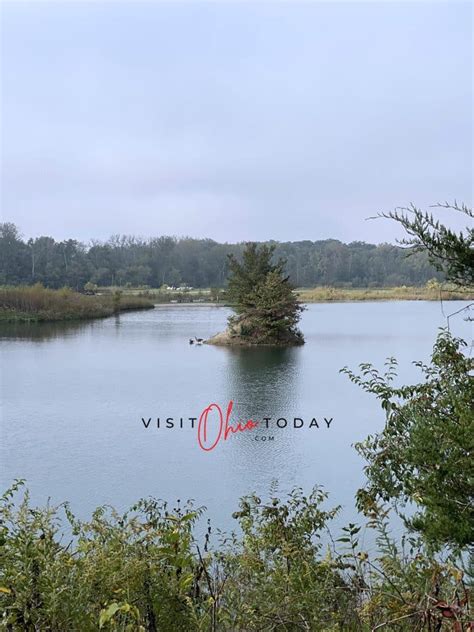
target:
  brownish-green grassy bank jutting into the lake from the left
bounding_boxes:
[0,285,153,322]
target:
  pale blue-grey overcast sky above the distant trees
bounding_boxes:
[1,1,473,242]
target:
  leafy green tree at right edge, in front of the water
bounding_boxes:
[342,332,474,548]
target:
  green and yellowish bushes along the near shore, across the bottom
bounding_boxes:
[0,483,468,632]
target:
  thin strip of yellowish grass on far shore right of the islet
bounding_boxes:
[296,283,474,303]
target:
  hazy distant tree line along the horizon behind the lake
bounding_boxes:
[0,223,443,289]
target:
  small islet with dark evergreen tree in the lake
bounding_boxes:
[208,243,304,346]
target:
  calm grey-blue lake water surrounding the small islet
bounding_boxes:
[0,301,472,540]
